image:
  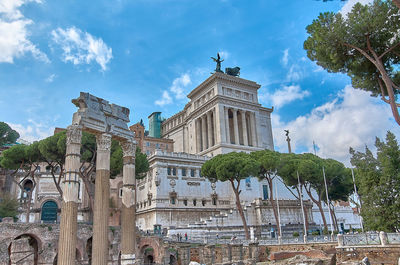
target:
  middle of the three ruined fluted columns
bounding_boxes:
[92,133,111,265]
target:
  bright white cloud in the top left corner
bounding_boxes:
[0,0,49,63]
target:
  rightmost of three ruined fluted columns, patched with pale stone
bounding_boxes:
[121,140,136,265]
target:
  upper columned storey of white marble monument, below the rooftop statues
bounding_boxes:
[162,72,273,156]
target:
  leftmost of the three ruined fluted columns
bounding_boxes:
[57,125,82,265]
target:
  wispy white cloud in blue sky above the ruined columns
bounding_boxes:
[51,27,113,71]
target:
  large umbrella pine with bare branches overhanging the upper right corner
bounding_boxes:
[304,0,400,125]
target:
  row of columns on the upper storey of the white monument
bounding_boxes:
[195,106,257,152]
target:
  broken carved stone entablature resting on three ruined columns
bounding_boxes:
[72,92,133,140]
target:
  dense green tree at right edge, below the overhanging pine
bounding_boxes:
[350,132,400,232]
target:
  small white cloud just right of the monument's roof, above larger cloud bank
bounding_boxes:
[260,85,310,108]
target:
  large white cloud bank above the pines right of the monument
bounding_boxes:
[272,86,400,164]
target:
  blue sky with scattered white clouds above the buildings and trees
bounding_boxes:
[0,0,400,164]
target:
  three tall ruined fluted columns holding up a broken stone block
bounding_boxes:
[58,124,136,265]
